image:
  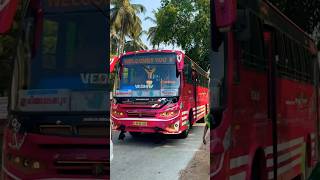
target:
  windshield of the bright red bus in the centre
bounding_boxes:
[115,54,180,97]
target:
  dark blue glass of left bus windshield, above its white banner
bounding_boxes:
[29,11,107,90]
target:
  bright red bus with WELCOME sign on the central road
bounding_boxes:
[111,50,208,138]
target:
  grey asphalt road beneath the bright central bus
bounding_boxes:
[111,124,204,180]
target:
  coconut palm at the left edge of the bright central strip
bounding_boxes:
[110,0,146,54]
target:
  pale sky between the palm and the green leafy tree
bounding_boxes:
[131,0,181,50]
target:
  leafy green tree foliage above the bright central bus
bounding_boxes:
[148,0,210,69]
